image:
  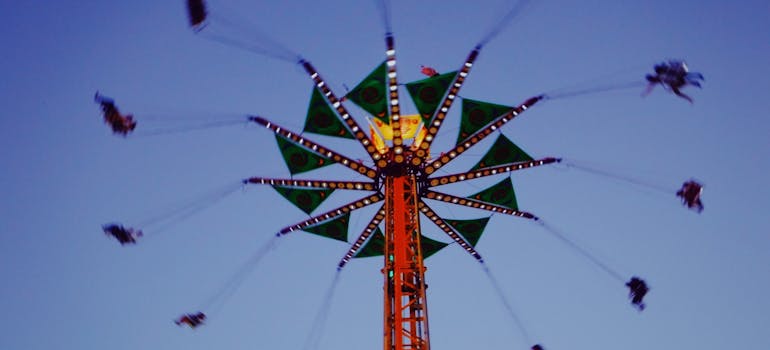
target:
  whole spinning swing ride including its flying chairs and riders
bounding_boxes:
[95,0,703,350]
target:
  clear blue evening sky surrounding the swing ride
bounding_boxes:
[0,0,770,350]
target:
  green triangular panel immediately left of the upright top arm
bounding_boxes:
[346,62,390,124]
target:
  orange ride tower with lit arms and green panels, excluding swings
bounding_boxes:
[247,35,544,350]
